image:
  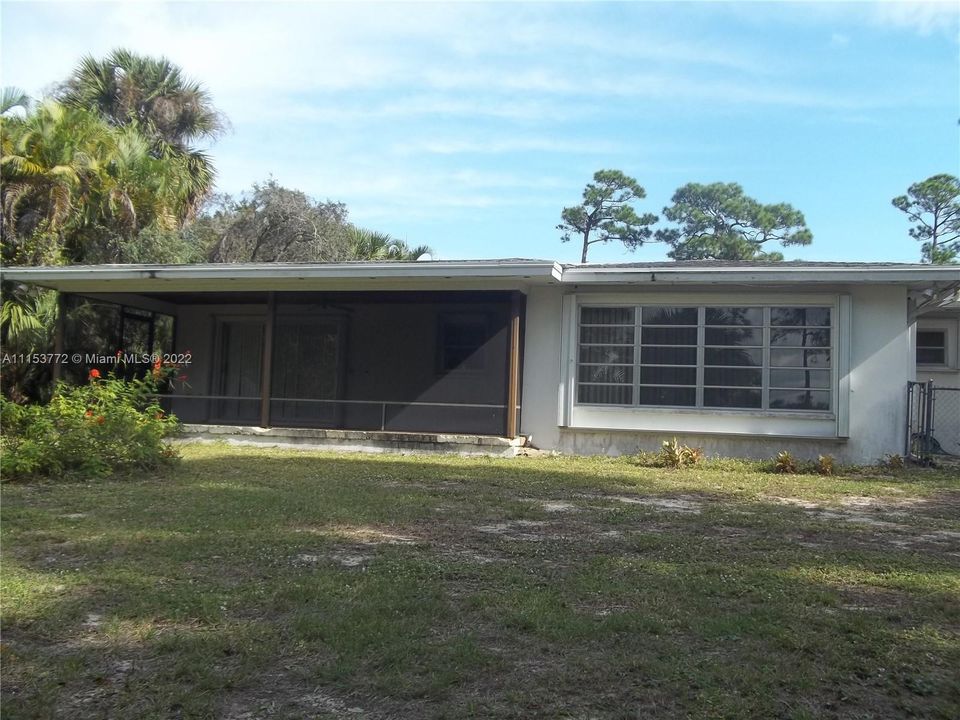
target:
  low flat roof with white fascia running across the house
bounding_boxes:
[0,258,960,293]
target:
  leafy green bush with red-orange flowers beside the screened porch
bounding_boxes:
[0,366,179,480]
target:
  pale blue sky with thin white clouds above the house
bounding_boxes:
[0,2,960,261]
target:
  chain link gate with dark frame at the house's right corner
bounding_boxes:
[904,380,960,462]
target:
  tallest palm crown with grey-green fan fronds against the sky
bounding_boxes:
[58,49,226,215]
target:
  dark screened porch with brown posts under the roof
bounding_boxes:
[65,291,523,437]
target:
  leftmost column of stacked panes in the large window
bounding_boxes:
[577,307,636,405]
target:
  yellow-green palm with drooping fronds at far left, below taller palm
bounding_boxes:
[0,100,192,264]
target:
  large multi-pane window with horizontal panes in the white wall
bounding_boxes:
[577,305,833,412]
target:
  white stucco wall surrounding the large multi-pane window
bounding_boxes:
[521,286,913,463]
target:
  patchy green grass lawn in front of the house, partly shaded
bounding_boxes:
[0,445,960,720]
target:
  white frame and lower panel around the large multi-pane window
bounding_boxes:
[557,288,853,438]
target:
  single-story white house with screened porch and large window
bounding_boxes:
[2,259,960,462]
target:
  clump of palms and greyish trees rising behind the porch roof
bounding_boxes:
[0,50,429,265]
